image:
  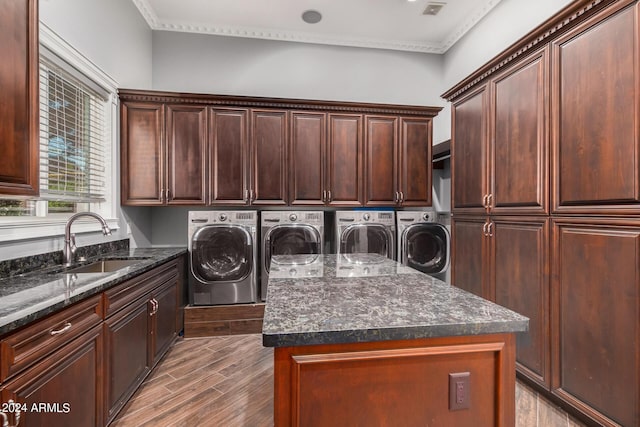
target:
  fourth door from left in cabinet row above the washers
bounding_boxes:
[251,110,288,205]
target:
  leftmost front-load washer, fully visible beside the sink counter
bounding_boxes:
[188,211,258,305]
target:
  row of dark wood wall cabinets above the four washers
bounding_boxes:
[120,90,440,206]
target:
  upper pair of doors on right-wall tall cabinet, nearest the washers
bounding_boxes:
[452,49,549,214]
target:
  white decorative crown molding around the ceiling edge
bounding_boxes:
[132,0,501,54]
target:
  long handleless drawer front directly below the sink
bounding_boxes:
[104,261,178,318]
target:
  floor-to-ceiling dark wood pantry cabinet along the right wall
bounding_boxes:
[443,0,640,426]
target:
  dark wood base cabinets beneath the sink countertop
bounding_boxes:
[0,258,184,427]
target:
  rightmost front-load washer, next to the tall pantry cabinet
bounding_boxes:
[396,211,451,281]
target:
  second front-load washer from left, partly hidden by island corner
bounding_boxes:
[260,211,324,301]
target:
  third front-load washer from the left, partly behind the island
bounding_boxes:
[335,210,396,262]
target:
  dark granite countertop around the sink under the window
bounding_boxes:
[0,248,187,335]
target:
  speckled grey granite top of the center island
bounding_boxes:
[262,254,529,347]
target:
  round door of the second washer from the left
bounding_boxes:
[263,224,322,273]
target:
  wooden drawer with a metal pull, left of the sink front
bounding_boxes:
[0,294,102,382]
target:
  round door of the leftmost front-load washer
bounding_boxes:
[191,224,253,283]
